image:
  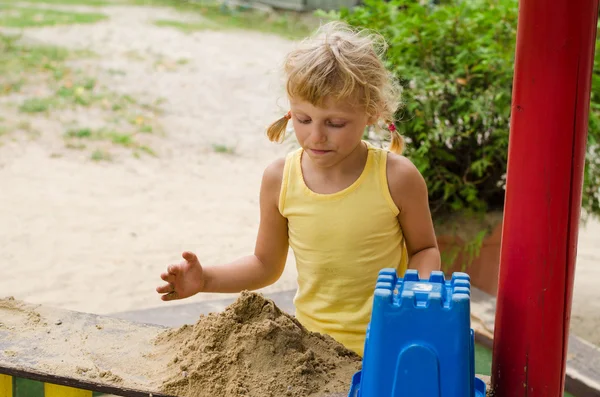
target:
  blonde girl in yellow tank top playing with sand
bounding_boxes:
[157,22,440,356]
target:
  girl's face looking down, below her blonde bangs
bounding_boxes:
[290,99,374,167]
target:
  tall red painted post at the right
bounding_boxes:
[492,0,598,397]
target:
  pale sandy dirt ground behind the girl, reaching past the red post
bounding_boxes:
[0,0,600,345]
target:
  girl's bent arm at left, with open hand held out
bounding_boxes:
[156,159,288,301]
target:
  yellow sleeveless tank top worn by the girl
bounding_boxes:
[279,142,408,356]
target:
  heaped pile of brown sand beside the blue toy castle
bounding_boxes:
[155,292,361,397]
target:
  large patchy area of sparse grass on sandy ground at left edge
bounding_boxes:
[0,34,162,161]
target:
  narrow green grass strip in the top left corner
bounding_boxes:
[0,4,107,28]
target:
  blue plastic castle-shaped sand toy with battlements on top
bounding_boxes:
[348,269,486,397]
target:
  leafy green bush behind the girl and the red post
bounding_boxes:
[329,0,600,219]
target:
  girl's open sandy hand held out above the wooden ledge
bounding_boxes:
[156,252,205,301]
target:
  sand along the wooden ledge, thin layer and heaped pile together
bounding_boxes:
[0,291,361,397]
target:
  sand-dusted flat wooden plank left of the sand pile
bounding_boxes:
[0,301,173,397]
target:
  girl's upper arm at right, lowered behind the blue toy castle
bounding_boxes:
[387,153,441,278]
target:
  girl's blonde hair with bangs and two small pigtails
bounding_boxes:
[267,22,404,153]
